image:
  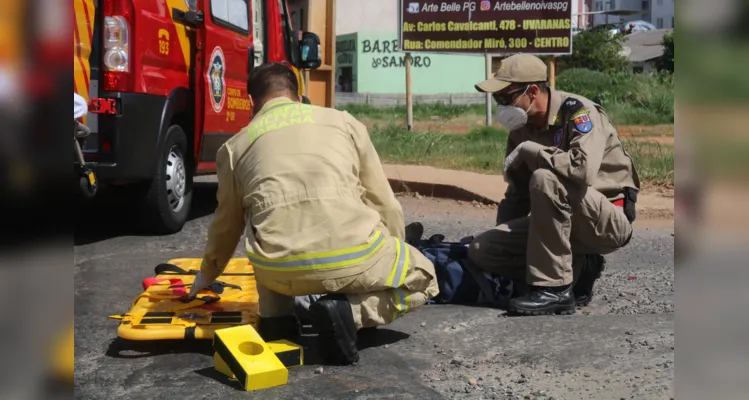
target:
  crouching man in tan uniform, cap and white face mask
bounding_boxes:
[468,54,640,315]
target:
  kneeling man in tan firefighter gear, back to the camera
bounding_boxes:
[191,63,439,364]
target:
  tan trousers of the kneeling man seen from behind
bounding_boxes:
[255,237,439,329]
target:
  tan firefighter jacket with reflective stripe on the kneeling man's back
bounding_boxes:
[201,98,405,279]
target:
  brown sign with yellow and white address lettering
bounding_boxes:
[399,0,572,55]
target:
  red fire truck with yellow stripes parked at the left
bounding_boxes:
[74,0,321,233]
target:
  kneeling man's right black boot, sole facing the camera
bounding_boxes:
[309,294,359,365]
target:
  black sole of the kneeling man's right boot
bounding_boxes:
[309,302,359,365]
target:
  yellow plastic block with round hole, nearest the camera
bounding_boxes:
[213,325,289,391]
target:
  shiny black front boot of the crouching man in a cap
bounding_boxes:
[508,285,575,315]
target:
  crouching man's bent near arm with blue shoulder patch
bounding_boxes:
[519,107,607,186]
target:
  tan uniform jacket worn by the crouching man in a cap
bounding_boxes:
[497,89,640,223]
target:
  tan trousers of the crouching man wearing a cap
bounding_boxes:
[468,169,632,286]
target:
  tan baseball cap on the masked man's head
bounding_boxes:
[476,54,547,93]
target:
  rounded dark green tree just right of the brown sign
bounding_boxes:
[558,30,631,72]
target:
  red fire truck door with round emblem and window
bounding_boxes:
[195,0,252,164]
